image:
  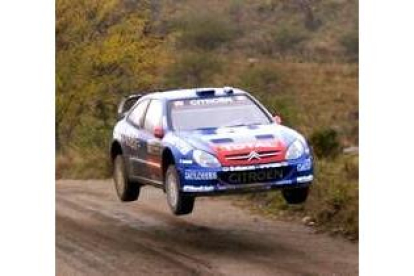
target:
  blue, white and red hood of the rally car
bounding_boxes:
[175,124,304,166]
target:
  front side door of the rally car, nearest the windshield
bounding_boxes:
[138,99,164,184]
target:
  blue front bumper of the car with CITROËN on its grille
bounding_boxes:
[178,157,314,196]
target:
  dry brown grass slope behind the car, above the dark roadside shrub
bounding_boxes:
[215,59,359,146]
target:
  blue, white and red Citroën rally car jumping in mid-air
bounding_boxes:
[110,87,313,215]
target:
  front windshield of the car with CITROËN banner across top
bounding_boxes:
[170,95,271,131]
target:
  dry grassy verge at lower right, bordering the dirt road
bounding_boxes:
[243,155,359,240]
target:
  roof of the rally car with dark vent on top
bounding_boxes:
[145,87,247,101]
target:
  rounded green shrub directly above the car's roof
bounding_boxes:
[165,52,222,87]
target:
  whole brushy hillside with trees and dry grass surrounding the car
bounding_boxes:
[56,0,358,238]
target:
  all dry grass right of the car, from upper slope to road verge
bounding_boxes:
[216,58,359,240]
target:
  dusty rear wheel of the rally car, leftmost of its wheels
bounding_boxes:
[113,155,141,201]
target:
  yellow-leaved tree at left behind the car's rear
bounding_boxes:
[56,0,165,150]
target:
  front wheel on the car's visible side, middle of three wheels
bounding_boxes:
[164,165,195,216]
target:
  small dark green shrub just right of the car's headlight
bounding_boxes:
[310,128,341,157]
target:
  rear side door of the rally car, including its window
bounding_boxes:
[123,100,150,178]
